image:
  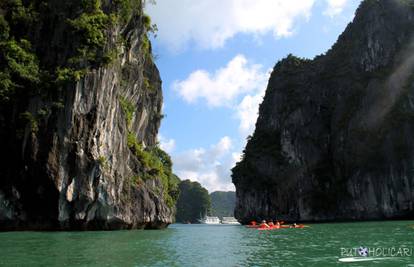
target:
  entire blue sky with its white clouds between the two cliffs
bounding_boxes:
[146,0,360,192]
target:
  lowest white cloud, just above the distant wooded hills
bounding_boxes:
[172,136,235,192]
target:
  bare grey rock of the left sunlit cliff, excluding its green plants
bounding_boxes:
[0,0,175,230]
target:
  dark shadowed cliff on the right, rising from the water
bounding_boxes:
[232,0,414,222]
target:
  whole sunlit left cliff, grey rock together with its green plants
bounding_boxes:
[0,0,177,230]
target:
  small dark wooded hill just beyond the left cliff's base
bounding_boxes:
[176,180,211,223]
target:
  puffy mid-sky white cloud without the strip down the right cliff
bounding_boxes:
[173,55,268,107]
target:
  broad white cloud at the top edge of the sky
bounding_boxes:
[147,0,315,51]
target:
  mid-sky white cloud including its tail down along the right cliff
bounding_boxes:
[173,55,270,138]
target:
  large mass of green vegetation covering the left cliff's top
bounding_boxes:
[0,0,156,102]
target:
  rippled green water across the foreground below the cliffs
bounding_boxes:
[0,221,414,267]
